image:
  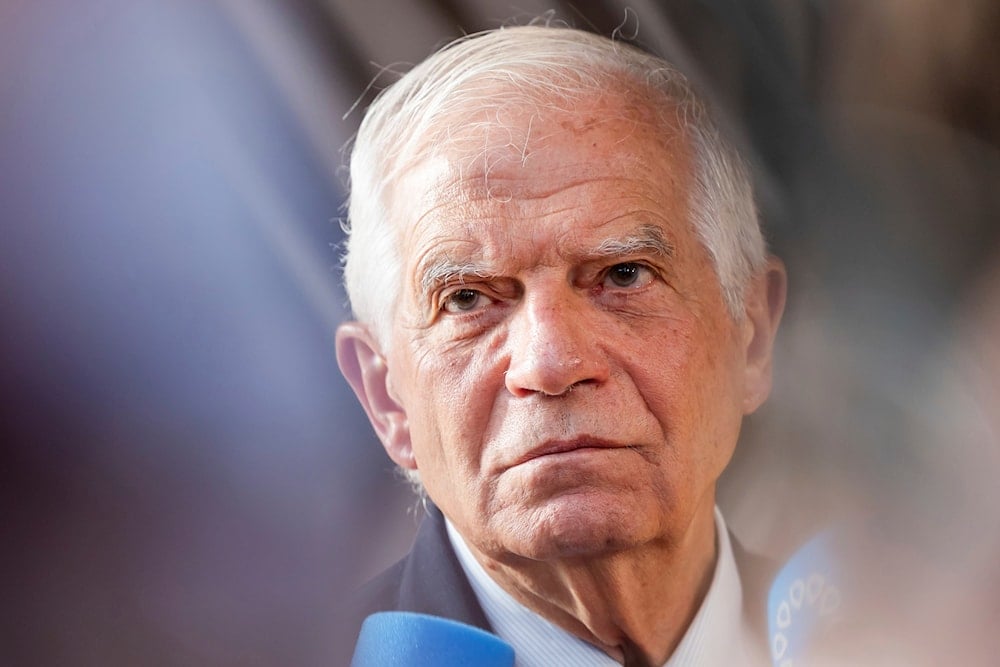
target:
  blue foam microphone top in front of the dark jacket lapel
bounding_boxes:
[351,611,514,667]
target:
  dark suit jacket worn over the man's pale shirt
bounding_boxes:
[334,506,777,665]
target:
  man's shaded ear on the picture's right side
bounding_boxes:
[743,257,788,414]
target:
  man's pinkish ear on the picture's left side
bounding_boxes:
[337,322,417,470]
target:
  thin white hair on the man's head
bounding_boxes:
[344,25,767,349]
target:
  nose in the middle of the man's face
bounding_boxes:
[505,294,609,397]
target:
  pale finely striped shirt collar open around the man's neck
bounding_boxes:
[448,508,768,667]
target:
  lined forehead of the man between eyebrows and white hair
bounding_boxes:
[393,98,691,266]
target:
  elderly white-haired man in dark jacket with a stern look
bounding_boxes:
[337,26,785,666]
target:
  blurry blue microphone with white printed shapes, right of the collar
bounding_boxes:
[767,531,842,667]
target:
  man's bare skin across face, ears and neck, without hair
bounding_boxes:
[338,94,784,665]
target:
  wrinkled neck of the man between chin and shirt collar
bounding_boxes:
[470,507,717,667]
